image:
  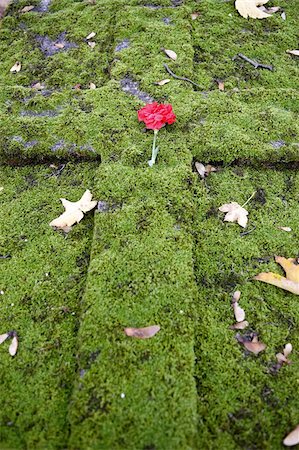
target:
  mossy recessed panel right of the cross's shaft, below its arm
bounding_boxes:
[195,168,299,449]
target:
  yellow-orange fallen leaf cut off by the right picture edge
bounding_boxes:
[254,256,299,295]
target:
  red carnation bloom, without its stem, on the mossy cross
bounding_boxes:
[138,102,176,130]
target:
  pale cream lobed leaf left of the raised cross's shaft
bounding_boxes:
[50,189,97,231]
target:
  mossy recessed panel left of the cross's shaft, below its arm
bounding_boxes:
[0,164,94,450]
